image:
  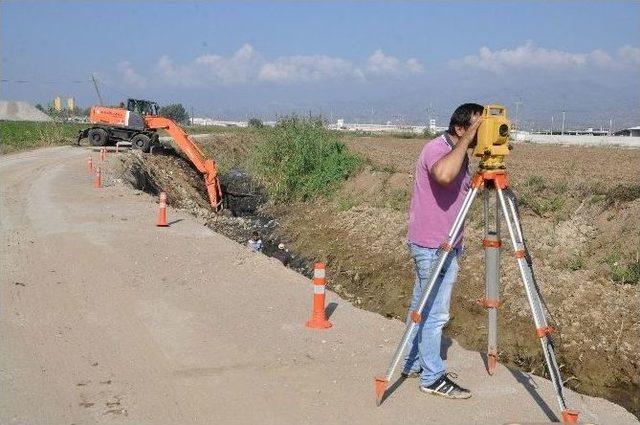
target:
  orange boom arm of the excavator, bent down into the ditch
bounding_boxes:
[144,115,222,210]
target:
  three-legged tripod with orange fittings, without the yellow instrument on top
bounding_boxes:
[375,164,578,423]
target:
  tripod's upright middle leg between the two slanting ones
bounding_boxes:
[478,188,501,375]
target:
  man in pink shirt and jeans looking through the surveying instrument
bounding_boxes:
[402,103,483,399]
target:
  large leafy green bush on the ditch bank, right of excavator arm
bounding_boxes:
[250,117,363,201]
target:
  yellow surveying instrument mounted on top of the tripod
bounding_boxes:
[473,105,511,170]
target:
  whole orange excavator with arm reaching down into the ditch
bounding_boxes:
[78,99,222,211]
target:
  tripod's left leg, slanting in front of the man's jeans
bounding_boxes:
[375,187,478,405]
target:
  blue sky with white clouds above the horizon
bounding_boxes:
[0,0,640,126]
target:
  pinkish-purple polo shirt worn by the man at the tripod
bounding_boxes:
[407,134,470,248]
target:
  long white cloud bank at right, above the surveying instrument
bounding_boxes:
[454,41,620,73]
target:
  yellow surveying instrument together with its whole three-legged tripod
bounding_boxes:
[375,105,579,423]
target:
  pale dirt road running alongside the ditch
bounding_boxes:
[0,148,638,425]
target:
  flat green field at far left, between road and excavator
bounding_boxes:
[0,121,87,154]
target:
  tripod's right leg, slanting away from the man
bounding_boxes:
[496,188,578,423]
